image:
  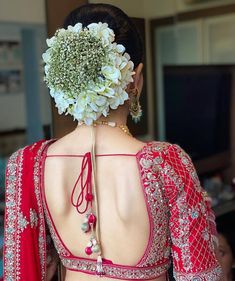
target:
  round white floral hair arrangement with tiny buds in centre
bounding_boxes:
[42,22,134,125]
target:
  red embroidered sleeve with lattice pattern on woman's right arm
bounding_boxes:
[165,145,223,281]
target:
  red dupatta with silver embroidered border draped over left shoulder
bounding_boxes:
[3,141,52,281]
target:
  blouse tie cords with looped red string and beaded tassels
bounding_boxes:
[71,127,105,277]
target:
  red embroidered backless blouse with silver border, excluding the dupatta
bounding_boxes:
[42,142,221,281]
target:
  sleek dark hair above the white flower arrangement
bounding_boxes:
[64,4,143,67]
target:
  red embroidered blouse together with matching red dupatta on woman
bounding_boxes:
[4,141,222,281]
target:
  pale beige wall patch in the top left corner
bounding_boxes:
[0,0,46,23]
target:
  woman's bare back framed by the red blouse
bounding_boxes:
[44,127,165,281]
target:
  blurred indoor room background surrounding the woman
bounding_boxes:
[0,0,235,275]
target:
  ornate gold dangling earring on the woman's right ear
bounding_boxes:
[129,88,142,123]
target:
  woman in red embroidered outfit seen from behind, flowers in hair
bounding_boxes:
[5,4,222,281]
